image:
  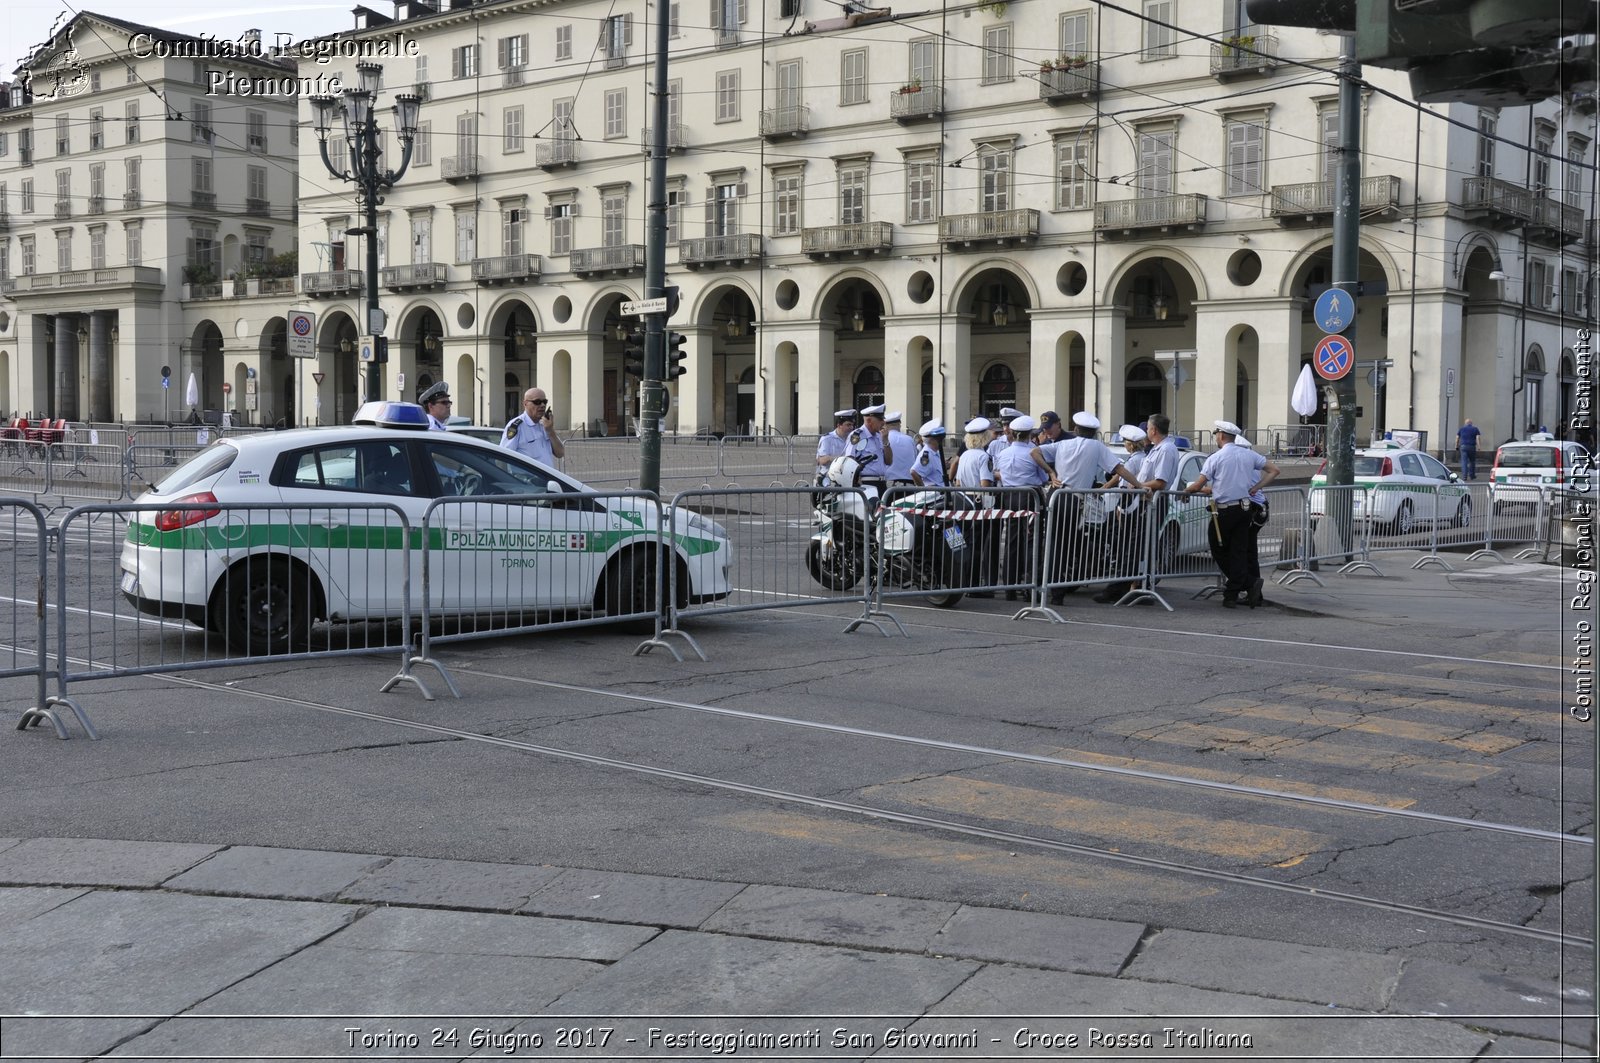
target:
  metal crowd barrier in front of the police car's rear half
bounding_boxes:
[44,503,432,726]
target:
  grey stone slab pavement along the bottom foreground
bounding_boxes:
[0,837,1594,1060]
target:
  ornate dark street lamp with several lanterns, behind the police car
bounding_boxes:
[310,62,422,400]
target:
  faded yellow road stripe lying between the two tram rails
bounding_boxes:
[862,776,1331,864]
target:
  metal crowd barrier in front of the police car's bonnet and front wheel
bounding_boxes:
[411,491,686,681]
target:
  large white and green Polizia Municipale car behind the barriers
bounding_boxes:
[122,403,730,653]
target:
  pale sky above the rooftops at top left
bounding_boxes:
[0,0,356,80]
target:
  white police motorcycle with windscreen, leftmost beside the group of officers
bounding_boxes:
[805,455,979,608]
